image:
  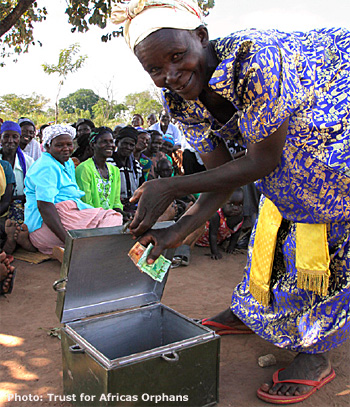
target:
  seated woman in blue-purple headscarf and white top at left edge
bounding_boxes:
[0,121,34,224]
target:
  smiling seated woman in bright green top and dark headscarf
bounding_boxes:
[75,127,123,220]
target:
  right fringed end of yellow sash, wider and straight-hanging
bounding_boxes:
[295,223,330,296]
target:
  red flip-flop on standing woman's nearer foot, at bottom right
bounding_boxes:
[256,369,335,404]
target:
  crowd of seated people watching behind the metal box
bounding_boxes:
[0,111,258,289]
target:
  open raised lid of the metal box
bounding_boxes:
[54,222,174,323]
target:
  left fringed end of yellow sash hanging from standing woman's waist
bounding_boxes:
[249,198,282,307]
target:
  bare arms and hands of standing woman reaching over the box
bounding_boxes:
[131,120,288,263]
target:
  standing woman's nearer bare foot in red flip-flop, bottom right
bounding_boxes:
[260,353,332,396]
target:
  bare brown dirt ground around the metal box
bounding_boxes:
[0,248,350,407]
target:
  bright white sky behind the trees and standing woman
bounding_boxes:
[0,0,350,110]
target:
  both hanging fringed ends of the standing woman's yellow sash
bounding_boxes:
[249,198,330,307]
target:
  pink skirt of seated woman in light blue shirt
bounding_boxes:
[29,201,123,254]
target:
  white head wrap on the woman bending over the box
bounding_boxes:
[111,0,204,51]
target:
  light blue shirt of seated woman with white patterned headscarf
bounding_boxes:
[24,153,92,233]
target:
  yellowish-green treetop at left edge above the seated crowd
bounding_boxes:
[0,93,49,121]
